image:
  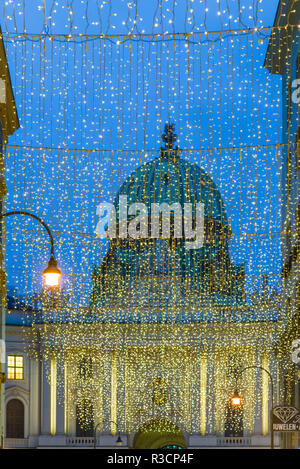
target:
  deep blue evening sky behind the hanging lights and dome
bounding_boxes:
[0,0,281,305]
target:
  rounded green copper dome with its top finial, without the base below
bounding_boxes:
[110,124,230,274]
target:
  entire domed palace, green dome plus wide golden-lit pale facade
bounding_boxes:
[6,125,281,448]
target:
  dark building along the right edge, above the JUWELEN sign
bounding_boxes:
[265,0,300,448]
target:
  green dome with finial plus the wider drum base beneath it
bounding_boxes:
[92,124,245,305]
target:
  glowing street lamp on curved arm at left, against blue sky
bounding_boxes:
[0,210,61,289]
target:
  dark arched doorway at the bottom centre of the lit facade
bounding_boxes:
[133,418,186,449]
